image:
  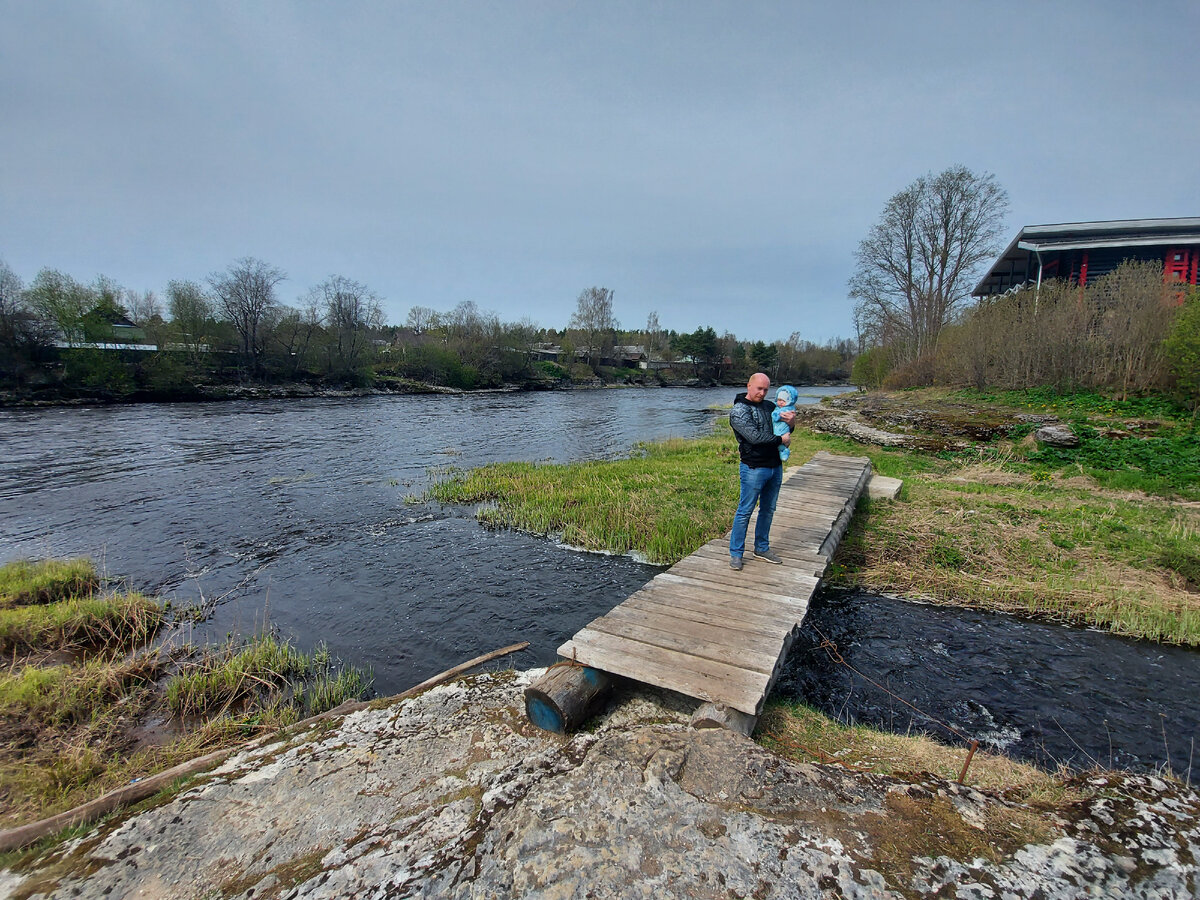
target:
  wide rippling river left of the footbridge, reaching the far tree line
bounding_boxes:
[0,388,816,694]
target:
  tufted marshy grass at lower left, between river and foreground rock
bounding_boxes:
[0,560,371,828]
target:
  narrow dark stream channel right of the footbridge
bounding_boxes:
[776,590,1200,776]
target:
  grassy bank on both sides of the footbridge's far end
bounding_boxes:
[432,391,1200,646]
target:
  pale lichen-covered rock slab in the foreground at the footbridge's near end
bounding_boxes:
[0,672,1200,900]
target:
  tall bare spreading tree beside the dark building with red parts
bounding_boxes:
[850,166,1008,360]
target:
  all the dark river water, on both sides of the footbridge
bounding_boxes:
[0,388,1200,773]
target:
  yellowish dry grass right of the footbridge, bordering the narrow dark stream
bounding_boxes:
[834,463,1200,646]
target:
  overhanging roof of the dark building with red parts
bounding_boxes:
[971,217,1200,296]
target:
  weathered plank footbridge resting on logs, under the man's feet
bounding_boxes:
[526,451,892,733]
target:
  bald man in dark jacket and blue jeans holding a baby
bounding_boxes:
[730,372,796,571]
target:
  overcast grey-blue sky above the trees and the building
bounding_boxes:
[0,0,1200,341]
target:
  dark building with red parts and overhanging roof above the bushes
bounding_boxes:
[971,218,1200,298]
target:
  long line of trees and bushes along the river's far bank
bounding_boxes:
[0,257,854,396]
